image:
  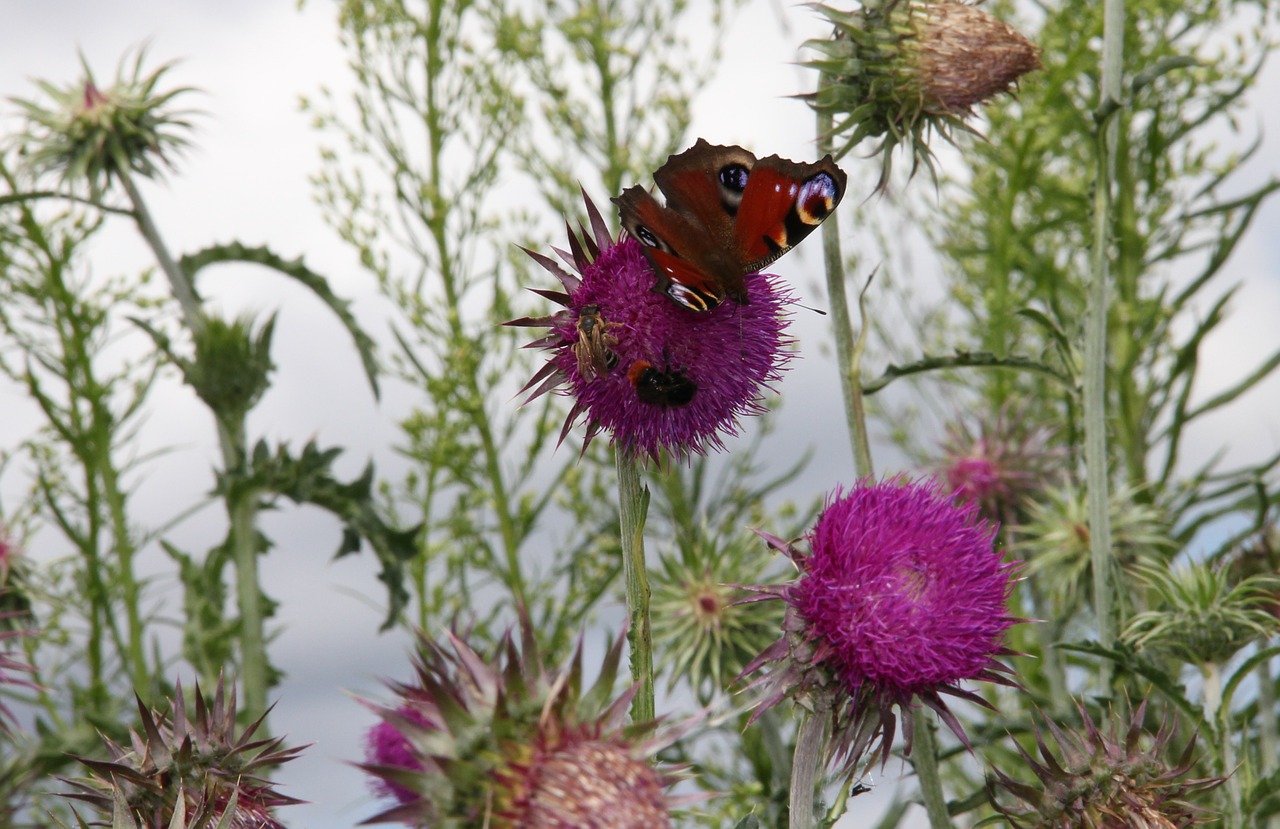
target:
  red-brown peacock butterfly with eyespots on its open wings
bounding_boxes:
[613,138,849,311]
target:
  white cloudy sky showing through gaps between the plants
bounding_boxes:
[0,0,1280,829]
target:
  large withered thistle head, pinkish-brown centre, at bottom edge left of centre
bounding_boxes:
[361,620,701,829]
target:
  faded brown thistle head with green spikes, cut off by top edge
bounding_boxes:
[803,0,1041,189]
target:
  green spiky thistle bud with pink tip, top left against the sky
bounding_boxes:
[15,49,192,198]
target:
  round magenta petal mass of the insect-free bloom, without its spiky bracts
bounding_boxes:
[788,481,1014,700]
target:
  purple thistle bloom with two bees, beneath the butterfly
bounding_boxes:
[507,196,792,457]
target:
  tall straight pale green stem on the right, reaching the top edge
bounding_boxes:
[1083,0,1124,691]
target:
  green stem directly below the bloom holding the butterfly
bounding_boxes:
[614,449,654,723]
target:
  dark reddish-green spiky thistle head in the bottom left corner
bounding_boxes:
[65,679,302,829]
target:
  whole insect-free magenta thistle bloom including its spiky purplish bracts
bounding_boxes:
[748,478,1018,773]
